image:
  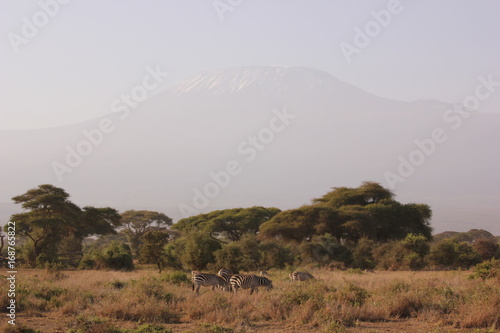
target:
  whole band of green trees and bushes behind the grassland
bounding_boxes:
[3,182,500,272]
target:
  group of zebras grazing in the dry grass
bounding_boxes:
[191,269,314,295]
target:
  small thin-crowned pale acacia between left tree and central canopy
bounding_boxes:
[120,210,172,255]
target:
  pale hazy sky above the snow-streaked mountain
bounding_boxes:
[0,0,500,129]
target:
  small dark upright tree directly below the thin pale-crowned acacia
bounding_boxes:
[139,230,170,273]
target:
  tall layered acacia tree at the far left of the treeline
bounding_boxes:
[11,184,120,263]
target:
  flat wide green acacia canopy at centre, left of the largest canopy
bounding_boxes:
[173,206,280,241]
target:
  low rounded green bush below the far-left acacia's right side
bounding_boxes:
[79,242,134,271]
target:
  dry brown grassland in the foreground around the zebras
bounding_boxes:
[0,267,500,333]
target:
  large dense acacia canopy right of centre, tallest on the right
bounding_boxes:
[260,182,432,244]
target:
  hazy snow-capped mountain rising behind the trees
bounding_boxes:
[0,66,500,234]
